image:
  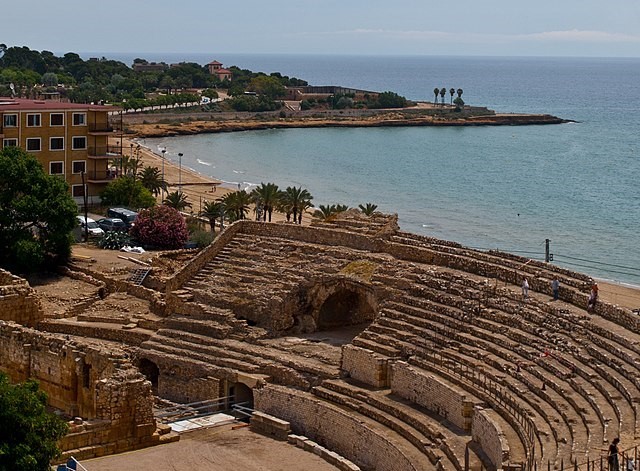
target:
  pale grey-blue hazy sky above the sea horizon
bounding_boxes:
[0,0,640,57]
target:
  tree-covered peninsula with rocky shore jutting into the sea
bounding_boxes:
[0,44,566,137]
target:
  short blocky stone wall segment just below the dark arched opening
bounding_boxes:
[340,344,389,388]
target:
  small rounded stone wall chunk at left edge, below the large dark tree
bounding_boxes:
[0,269,44,326]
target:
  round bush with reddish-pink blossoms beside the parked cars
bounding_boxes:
[131,205,189,249]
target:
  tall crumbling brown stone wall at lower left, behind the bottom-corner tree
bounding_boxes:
[0,321,157,457]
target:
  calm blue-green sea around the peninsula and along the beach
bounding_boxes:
[90,54,640,286]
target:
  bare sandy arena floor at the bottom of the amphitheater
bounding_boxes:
[82,425,338,471]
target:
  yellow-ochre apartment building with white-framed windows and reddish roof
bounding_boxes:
[0,98,122,205]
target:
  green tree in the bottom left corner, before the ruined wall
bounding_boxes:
[0,373,68,471]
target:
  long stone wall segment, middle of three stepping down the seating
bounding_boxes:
[391,361,479,431]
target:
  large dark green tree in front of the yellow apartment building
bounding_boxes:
[0,147,78,271]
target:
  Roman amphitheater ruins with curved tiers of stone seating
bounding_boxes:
[0,212,640,471]
